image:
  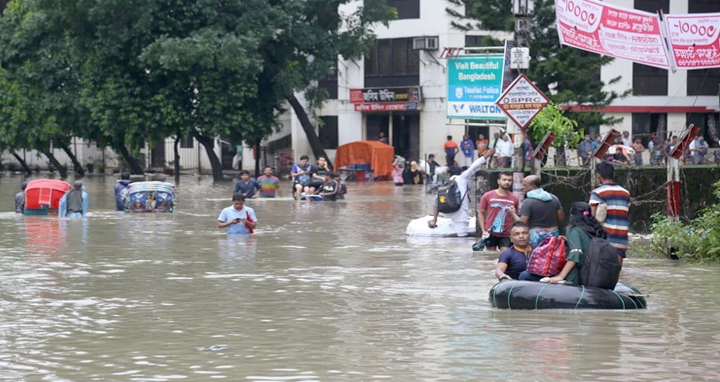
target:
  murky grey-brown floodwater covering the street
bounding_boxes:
[0,176,720,381]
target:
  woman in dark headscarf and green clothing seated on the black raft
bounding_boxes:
[541,202,607,284]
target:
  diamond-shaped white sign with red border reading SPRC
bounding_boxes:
[496,74,550,130]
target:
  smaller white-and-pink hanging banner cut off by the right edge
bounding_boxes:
[665,13,720,69]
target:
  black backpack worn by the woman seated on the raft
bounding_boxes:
[580,236,622,289]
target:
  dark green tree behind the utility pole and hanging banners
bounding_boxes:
[447,0,630,130]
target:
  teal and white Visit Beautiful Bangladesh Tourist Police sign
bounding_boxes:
[447,53,506,119]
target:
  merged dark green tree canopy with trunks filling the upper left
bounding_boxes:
[0,0,394,179]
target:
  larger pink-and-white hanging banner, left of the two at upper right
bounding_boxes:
[555,0,670,69]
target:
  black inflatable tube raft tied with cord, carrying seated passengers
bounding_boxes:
[490,280,647,309]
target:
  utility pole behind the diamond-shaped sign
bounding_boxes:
[507,0,535,200]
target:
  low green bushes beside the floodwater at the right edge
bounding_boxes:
[651,181,720,262]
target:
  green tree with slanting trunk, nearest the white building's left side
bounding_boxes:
[254,0,396,163]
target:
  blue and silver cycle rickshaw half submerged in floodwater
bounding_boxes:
[125,181,175,212]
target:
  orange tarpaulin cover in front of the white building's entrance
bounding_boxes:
[335,141,395,177]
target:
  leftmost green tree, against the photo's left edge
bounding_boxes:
[0,1,84,177]
